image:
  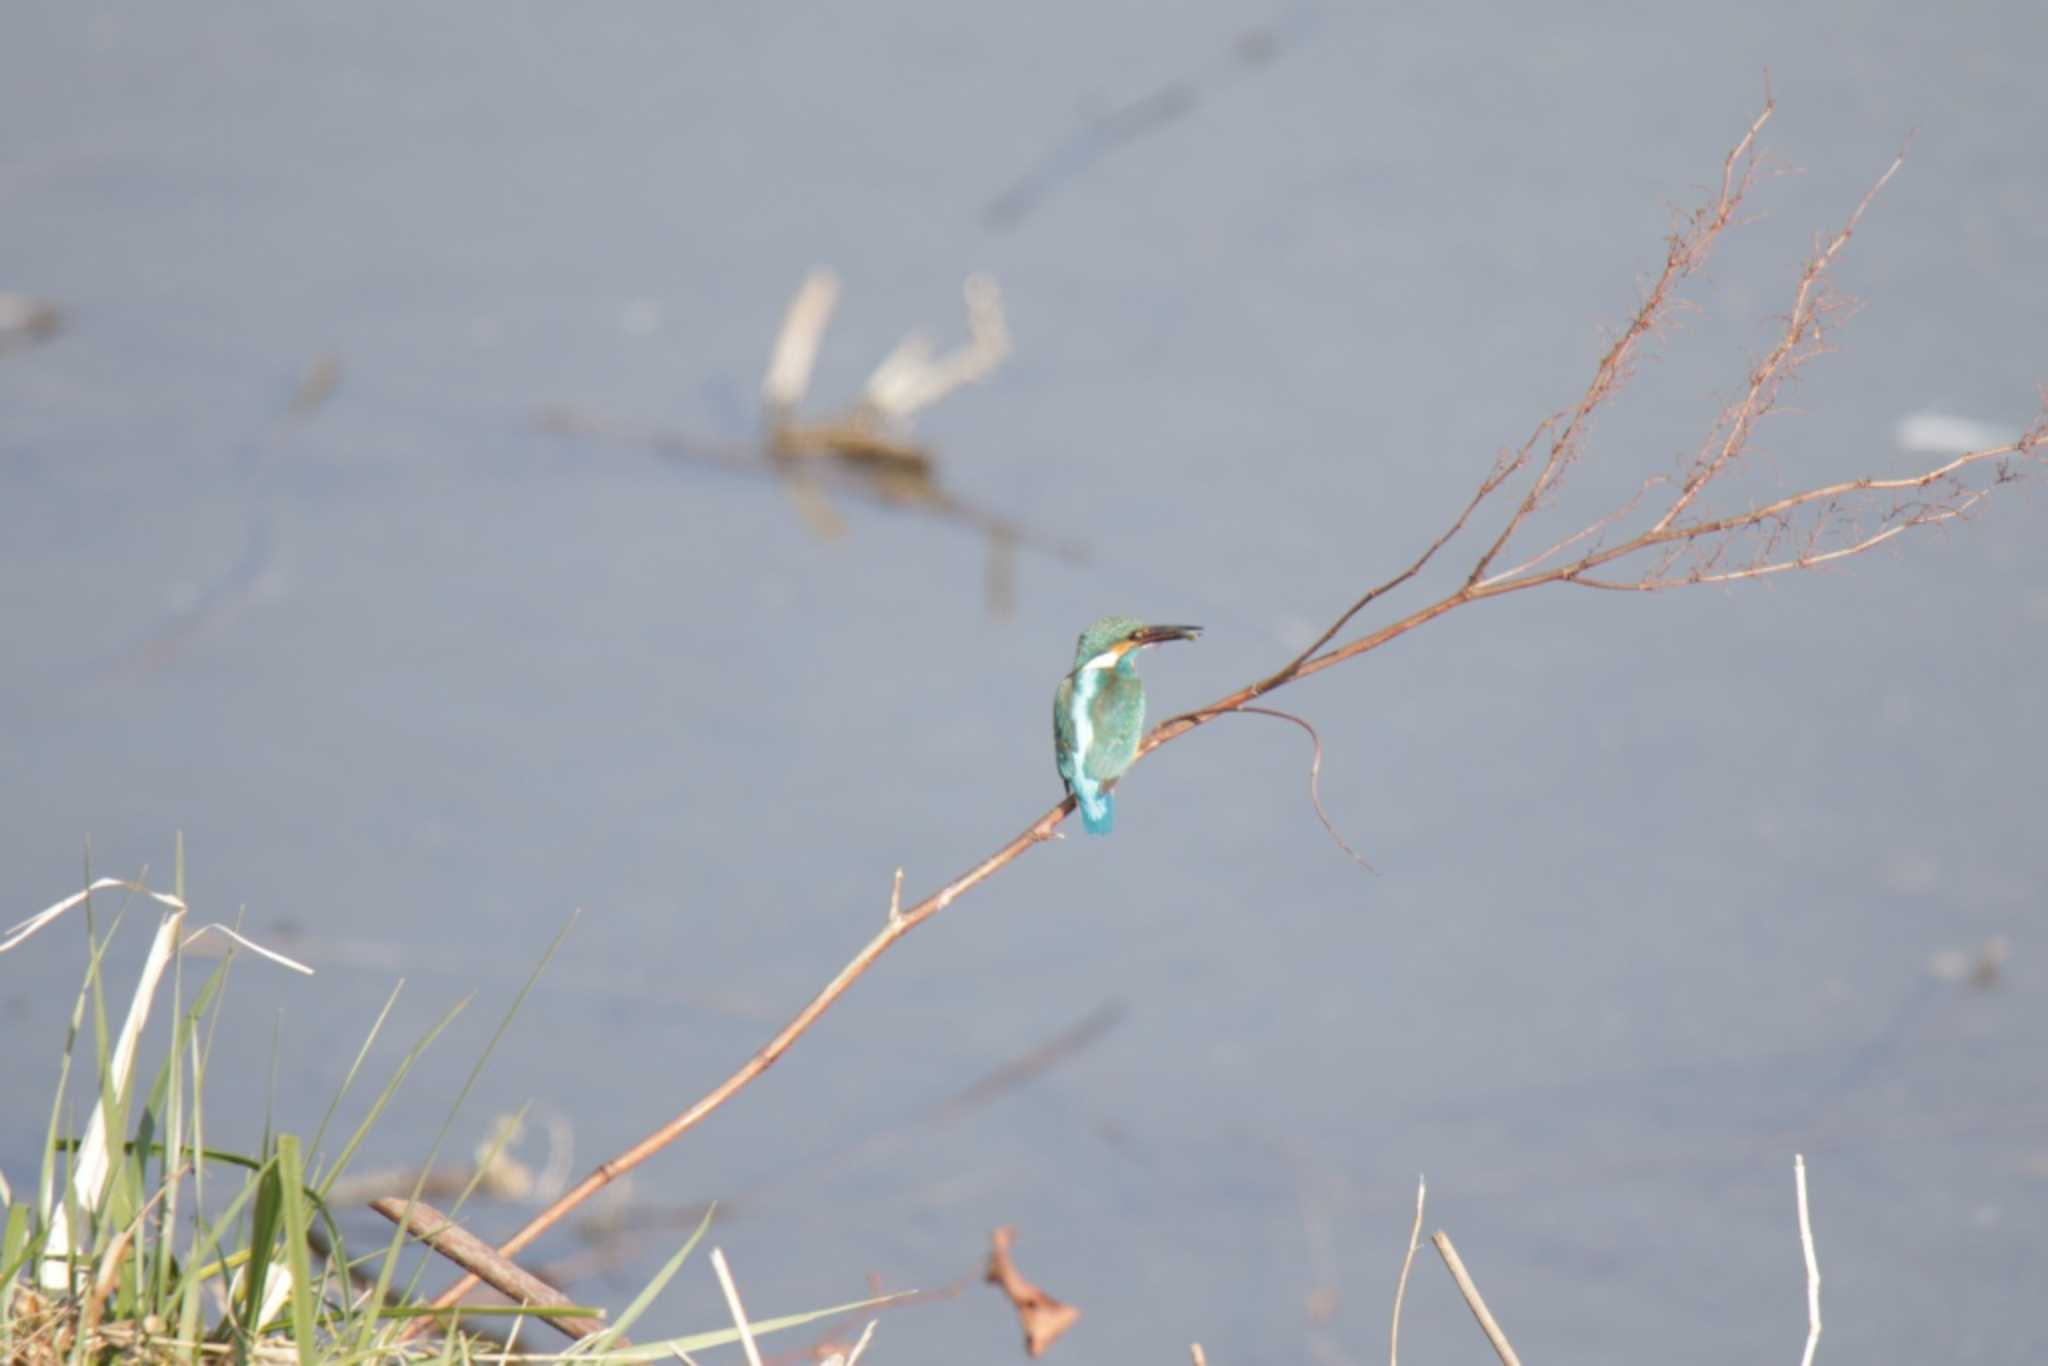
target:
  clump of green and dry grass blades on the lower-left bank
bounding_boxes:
[0,844,897,1366]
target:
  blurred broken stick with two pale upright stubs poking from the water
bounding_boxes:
[537,268,1087,616]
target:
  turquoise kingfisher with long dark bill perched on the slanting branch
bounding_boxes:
[1053,616,1202,836]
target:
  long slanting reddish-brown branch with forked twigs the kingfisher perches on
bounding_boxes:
[419,94,2048,1327]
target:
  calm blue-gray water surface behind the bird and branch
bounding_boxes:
[0,2,2048,1362]
